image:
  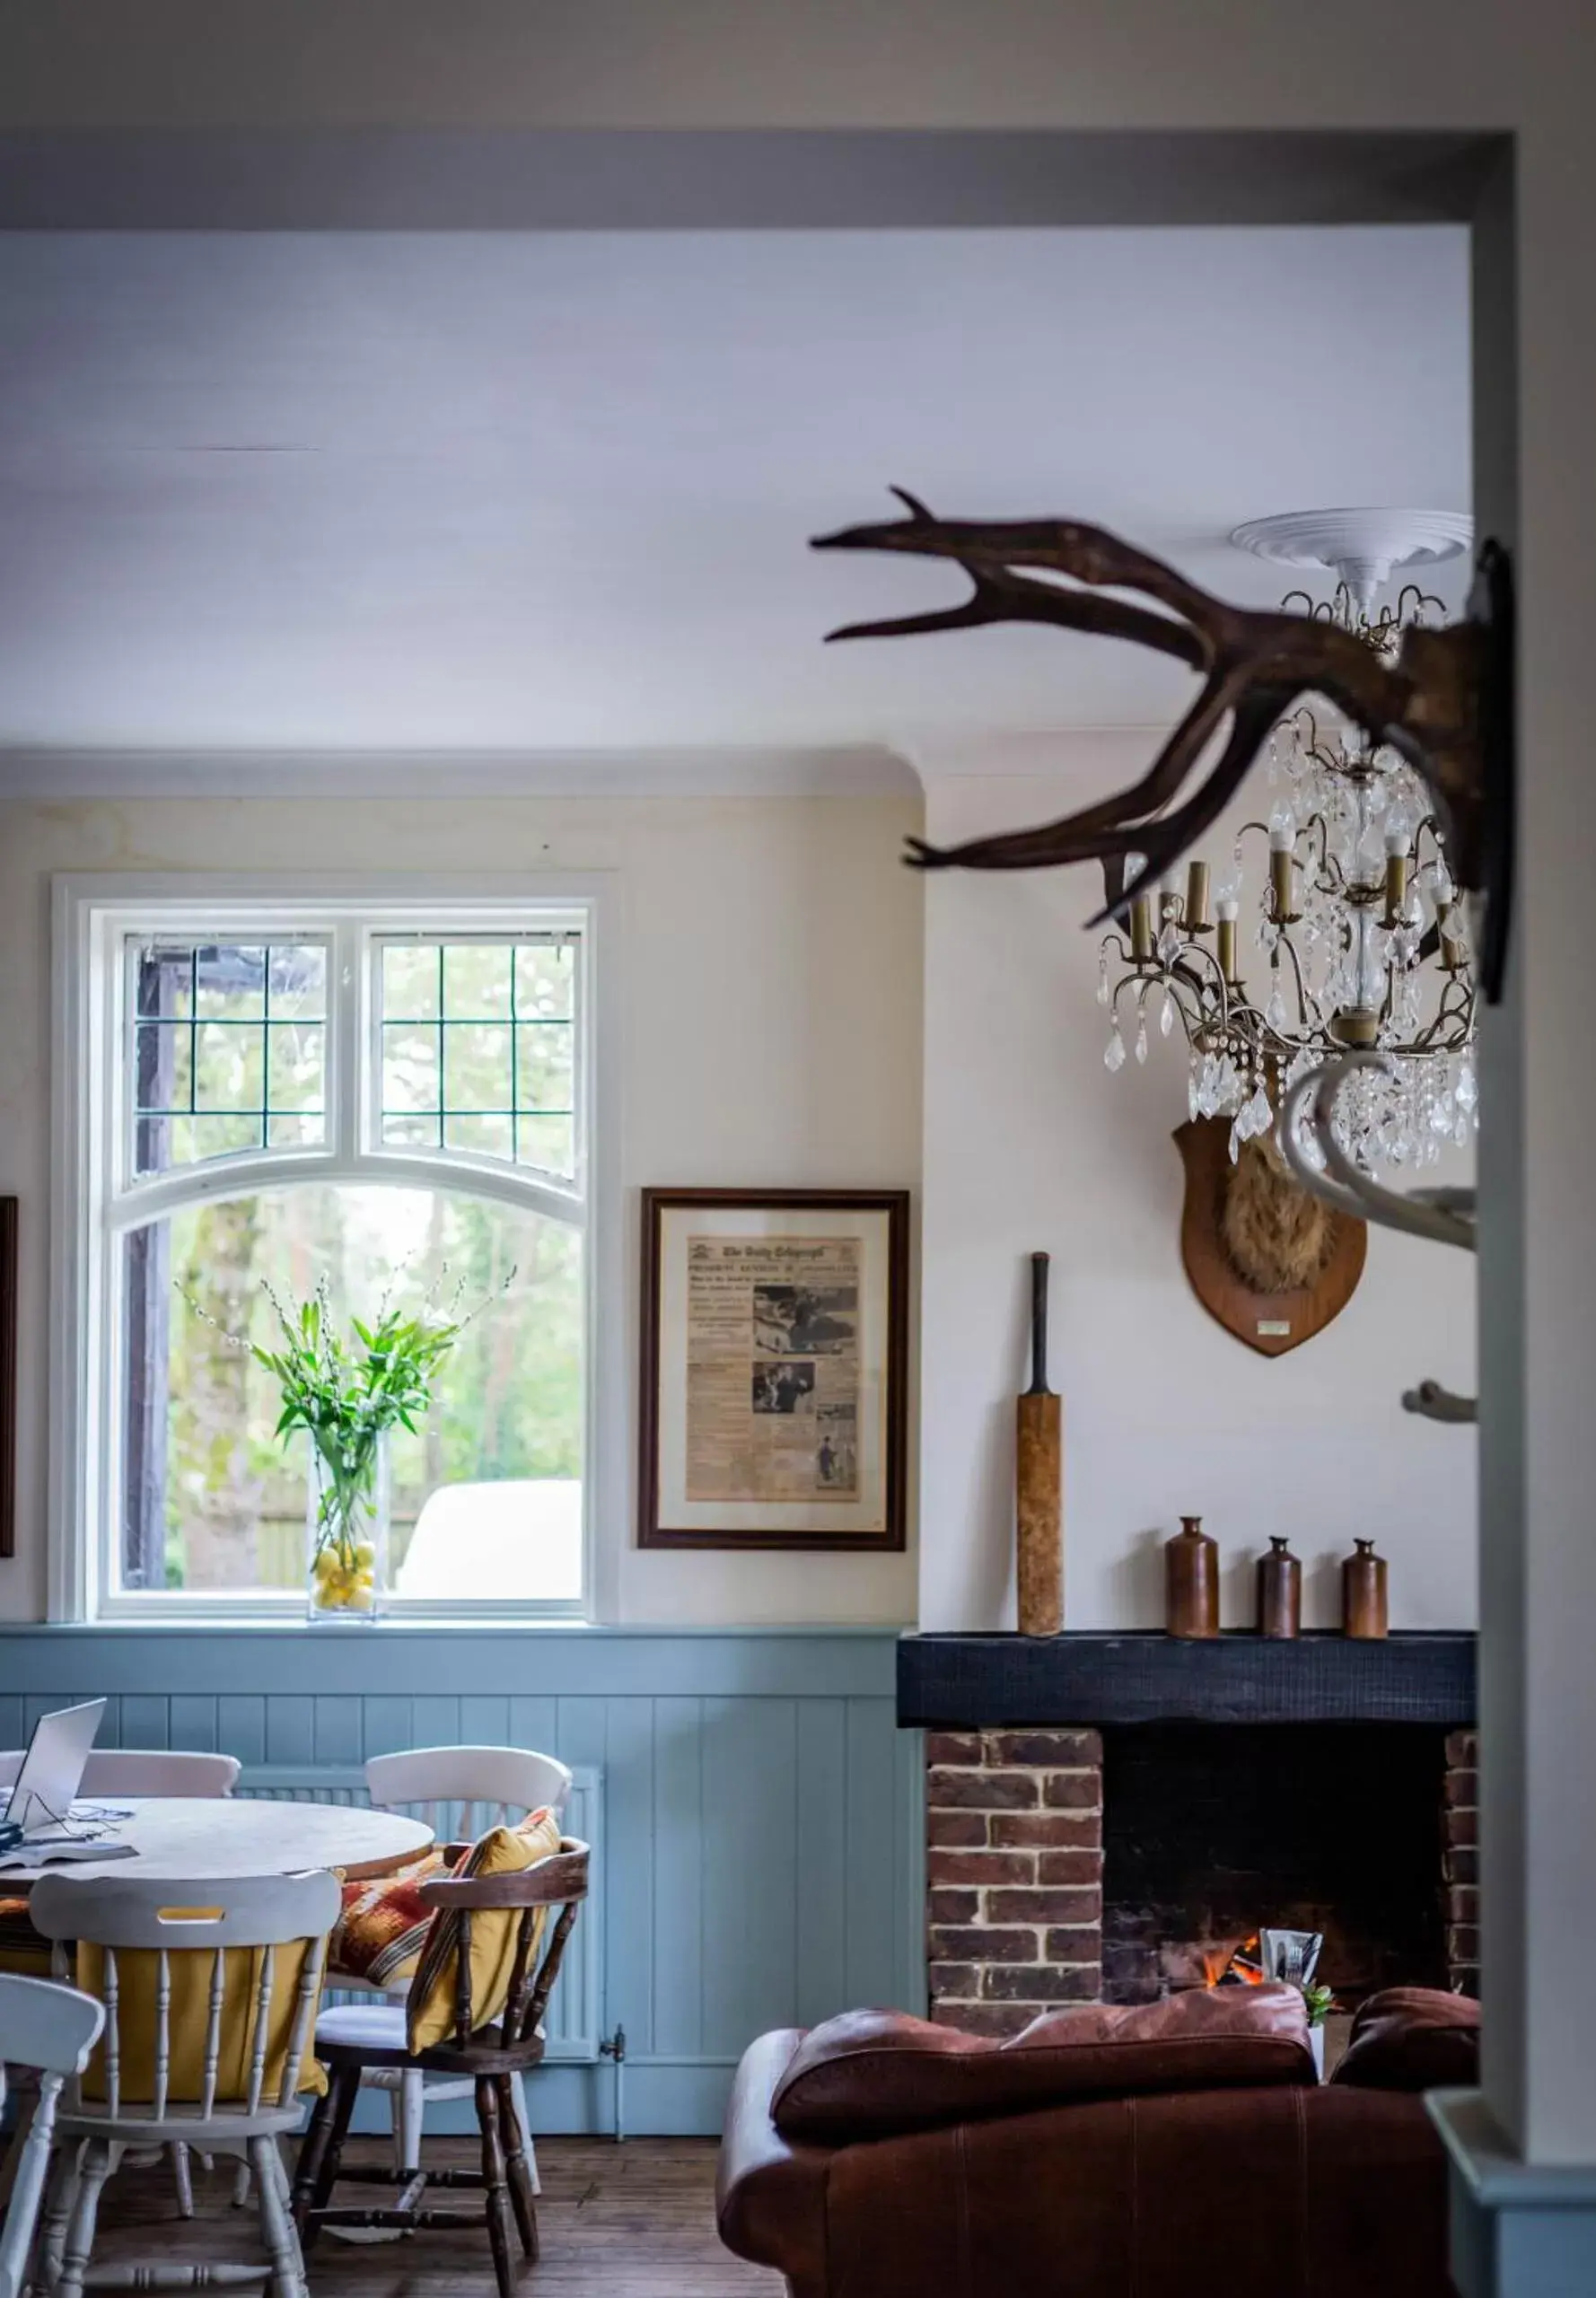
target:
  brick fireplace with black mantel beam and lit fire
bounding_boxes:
[898,1636,1477,2034]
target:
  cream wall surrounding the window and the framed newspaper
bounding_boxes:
[0,791,921,1625]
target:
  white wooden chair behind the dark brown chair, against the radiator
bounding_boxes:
[358,1747,572,2195]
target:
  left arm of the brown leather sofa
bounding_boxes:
[715,2027,829,2298]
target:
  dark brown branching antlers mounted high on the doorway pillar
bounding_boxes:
[813,487,1513,1002]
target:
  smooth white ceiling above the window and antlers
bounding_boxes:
[0,225,1468,751]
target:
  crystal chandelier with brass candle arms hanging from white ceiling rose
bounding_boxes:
[1098,510,1479,1170]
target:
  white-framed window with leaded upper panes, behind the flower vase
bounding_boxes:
[55,896,592,1618]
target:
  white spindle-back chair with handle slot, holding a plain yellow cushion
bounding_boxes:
[32,1873,340,2298]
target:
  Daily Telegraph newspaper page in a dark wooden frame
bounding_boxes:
[638,1188,909,1551]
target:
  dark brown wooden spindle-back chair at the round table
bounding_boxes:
[294,1836,588,2298]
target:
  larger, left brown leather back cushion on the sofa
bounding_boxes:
[772,1986,1318,2146]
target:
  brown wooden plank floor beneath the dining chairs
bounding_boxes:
[94,2139,785,2298]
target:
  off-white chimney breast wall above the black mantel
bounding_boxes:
[921,733,1477,1627]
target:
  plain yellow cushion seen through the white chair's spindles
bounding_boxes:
[78,1940,326,2112]
